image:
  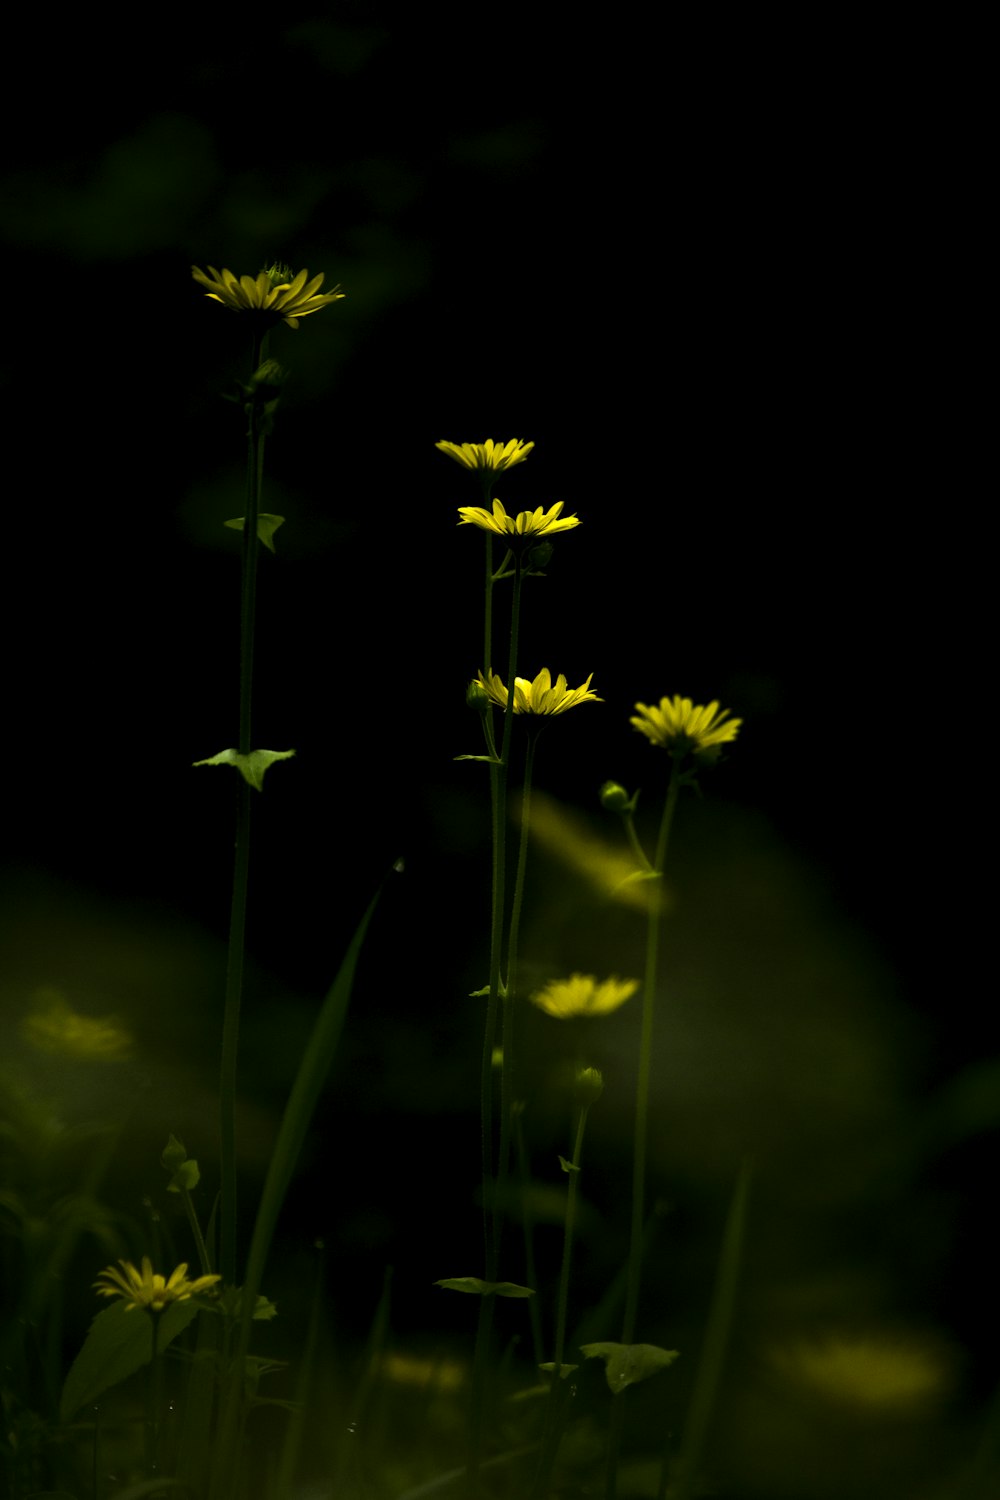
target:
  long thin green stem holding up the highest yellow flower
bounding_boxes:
[219,333,265,1286]
